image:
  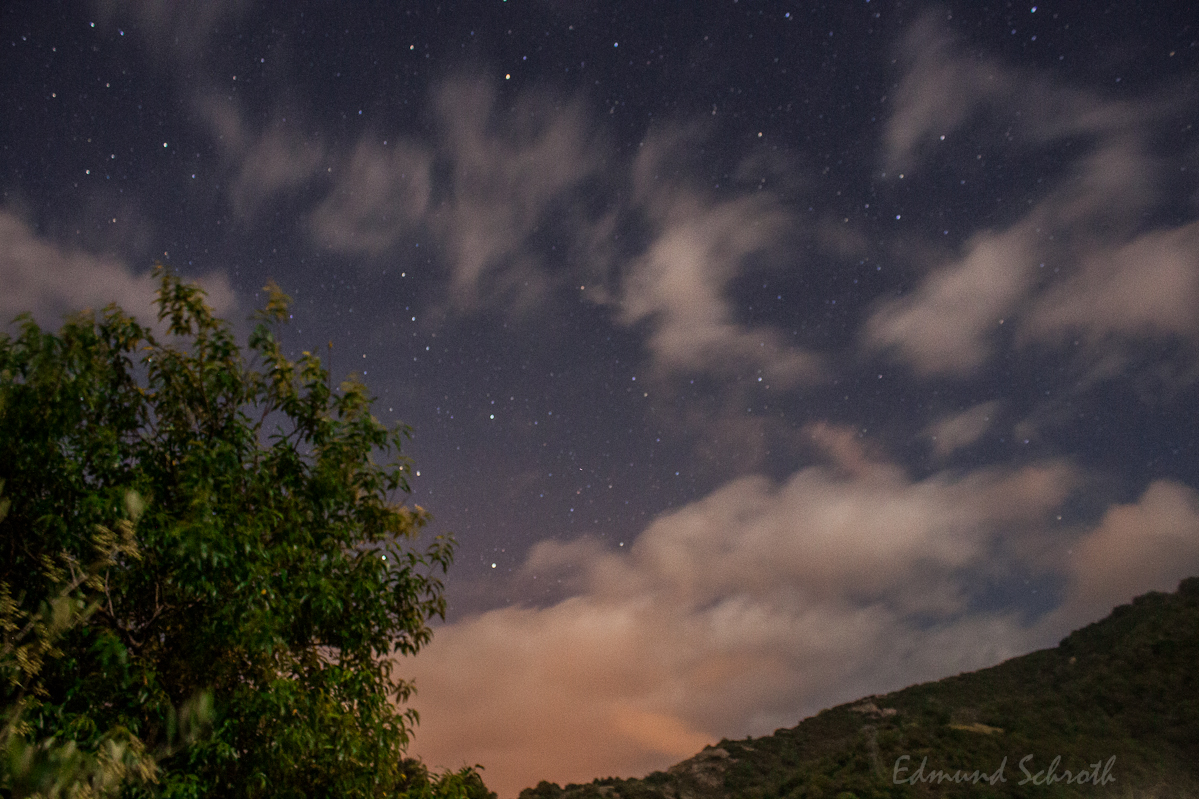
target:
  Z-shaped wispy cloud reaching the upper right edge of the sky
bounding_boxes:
[861,17,1199,378]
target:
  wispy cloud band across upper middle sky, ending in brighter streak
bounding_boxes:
[299,77,823,405]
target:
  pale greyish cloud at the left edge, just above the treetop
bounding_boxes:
[0,210,237,329]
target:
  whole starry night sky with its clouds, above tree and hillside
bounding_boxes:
[0,0,1199,799]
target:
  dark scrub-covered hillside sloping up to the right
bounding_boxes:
[520,577,1199,799]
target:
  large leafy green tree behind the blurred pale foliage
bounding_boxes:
[0,268,486,797]
